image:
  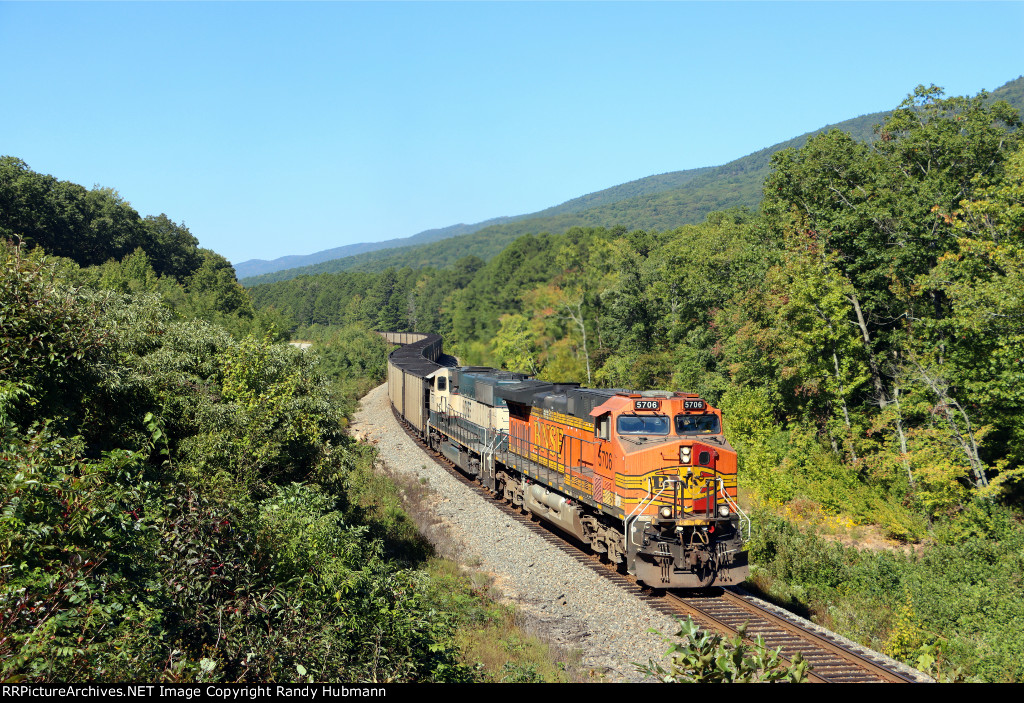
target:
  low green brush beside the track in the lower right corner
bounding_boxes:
[751,509,1024,682]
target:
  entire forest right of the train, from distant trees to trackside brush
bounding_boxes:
[251,87,1024,680]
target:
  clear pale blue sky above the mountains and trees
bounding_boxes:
[0,1,1024,263]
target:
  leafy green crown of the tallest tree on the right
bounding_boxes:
[765,86,1020,374]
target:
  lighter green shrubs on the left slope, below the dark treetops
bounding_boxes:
[0,244,470,682]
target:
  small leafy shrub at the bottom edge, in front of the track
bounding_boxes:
[635,618,810,684]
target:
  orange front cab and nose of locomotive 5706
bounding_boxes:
[592,392,749,587]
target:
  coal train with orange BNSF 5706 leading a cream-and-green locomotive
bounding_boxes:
[388,334,750,588]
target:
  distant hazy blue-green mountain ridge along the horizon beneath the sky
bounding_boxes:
[236,77,1024,287]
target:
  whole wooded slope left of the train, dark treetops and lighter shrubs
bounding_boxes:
[0,163,544,684]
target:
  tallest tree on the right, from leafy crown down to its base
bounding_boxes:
[765,86,1020,501]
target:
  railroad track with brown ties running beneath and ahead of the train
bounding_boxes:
[391,407,929,684]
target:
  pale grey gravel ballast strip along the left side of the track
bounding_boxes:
[351,384,678,682]
